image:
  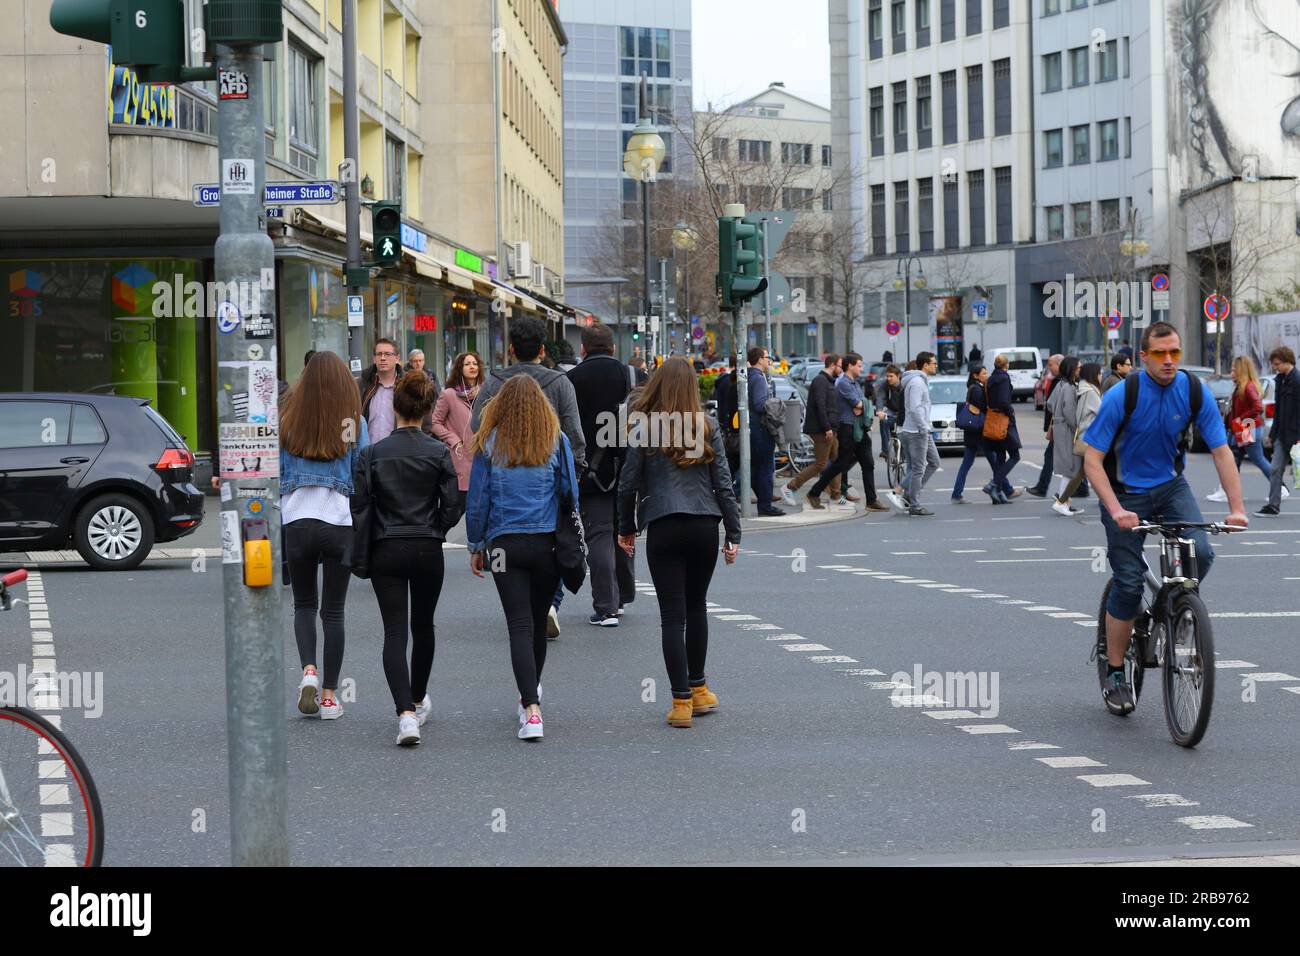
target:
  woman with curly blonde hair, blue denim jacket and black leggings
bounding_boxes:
[465,375,579,740]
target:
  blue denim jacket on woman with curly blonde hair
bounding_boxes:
[465,432,579,554]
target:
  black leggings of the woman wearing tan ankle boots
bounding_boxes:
[646,515,722,697]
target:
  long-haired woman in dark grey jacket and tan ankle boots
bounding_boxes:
[618,356,740,727]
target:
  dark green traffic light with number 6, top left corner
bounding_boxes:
[49,0,190,83]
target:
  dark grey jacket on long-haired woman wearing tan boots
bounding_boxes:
[618,425,740,544]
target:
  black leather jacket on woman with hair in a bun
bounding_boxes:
[352,428,464,541]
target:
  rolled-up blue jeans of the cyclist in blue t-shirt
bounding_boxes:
[1099,476,1214,620]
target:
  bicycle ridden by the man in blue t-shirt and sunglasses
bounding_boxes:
[1089,519,1242,747]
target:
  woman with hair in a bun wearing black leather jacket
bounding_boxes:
[352,372,463,747]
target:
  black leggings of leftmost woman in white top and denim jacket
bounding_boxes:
[285,518,352,691]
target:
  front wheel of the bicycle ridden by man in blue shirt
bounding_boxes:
[1165,592,1214,747]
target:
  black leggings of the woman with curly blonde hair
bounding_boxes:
[486,531,560,708]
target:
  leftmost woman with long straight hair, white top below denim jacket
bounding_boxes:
[280,351,368,721]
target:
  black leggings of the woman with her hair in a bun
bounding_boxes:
[371,537,442,714]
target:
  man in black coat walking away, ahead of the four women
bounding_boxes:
[568,324,636,627]
